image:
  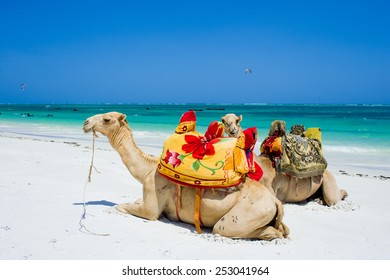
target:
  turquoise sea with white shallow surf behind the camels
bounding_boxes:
[0,104,390,175]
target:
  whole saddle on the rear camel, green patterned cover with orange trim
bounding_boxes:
[260,121,327,178]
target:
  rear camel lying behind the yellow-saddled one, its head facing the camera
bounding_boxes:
[222,114,348,206]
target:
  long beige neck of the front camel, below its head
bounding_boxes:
[108,126,158,183]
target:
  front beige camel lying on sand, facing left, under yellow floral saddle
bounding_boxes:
[83,112,289,240]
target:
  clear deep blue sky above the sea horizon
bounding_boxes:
[0,0,390,104]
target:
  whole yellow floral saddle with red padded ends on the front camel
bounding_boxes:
[158,111,263,189]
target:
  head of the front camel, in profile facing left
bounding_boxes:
[83,112,127,136]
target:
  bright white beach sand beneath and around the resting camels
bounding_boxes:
[0,133,390,276]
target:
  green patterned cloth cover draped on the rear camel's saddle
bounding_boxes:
[275,134,327,178]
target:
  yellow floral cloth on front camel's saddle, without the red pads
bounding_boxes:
[158,132,249,188]
